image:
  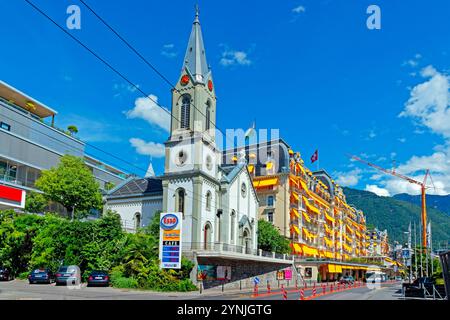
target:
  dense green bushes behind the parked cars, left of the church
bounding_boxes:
[0,211,196,291]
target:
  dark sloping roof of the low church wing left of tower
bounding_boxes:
[108,177,163,197]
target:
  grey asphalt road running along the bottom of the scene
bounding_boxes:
[0,280,402,300]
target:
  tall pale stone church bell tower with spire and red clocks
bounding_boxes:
[162,8,221,249]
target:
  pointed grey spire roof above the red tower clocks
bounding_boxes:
[183,6,209,83]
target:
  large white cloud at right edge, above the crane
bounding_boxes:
[399,66,450,138]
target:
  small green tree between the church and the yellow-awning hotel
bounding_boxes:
[258,219,290,253]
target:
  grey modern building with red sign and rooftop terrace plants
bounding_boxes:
[0,80,127,210]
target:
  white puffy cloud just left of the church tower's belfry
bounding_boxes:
[125,95,170,132]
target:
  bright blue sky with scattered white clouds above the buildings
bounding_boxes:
[0,0,450,194]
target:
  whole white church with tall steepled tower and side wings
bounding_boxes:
[105,12,293,286]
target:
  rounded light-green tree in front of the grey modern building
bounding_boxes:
[36,155,102,220]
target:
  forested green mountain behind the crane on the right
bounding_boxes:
[344,188,450,245]
